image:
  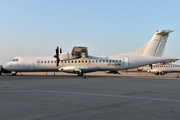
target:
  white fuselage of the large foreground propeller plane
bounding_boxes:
[3,55,170,73]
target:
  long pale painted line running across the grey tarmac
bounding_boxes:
[0,90,180,103]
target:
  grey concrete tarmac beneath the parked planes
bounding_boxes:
[0,73,180,120]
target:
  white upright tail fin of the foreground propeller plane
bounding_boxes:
[125,30,173,57]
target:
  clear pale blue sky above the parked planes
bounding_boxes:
[0,0,180,64]
